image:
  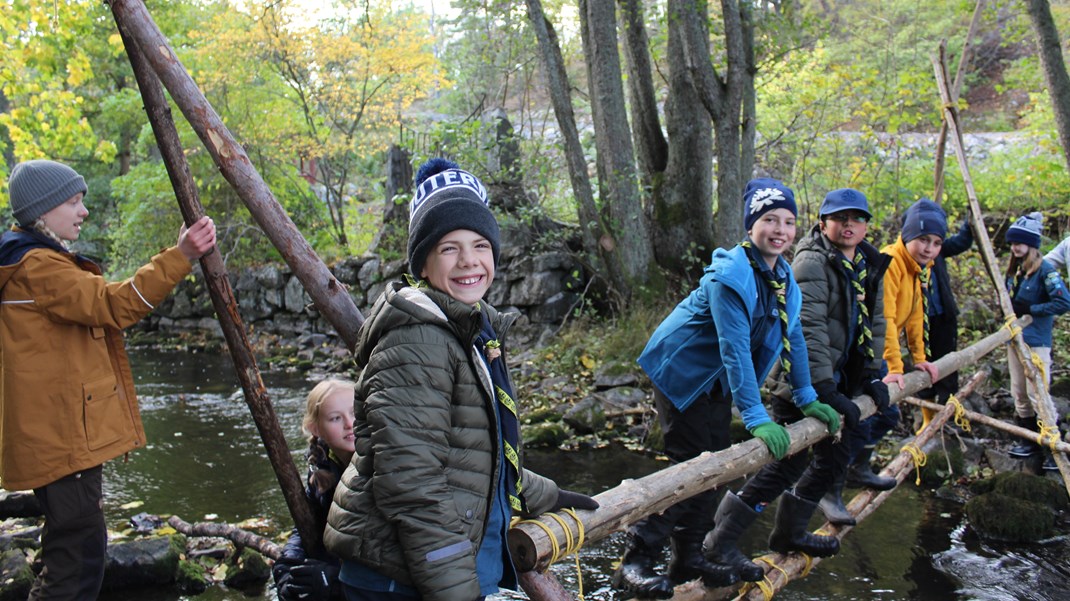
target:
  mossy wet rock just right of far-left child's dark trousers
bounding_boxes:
[103,536,185,590]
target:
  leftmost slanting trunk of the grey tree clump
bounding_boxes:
[526,0,631,302]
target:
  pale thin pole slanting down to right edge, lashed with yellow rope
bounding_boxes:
[932,57,1070,493]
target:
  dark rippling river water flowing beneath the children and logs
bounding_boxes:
[101,350,1070,601]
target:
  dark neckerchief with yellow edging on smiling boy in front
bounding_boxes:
[475,311,526,512]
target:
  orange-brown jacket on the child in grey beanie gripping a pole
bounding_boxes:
[0,235,190,490]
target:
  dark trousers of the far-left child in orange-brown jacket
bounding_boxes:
[29,465,108,601]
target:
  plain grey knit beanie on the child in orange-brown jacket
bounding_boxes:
[7,158,89,227]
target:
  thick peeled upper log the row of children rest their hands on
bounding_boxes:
[508,318,1014,572]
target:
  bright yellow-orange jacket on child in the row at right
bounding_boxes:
[881,237,932,373]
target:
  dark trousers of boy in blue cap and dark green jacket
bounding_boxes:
[739,395,857,507]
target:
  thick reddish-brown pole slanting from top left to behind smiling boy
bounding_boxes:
[111,0,364,350]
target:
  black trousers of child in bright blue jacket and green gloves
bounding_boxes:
[629,385,732,549]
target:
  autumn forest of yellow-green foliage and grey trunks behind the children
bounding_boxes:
[0,0,1070,367]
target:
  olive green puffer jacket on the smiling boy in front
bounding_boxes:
[323,282,557,601]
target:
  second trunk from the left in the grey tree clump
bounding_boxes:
[579,0,656,288]
